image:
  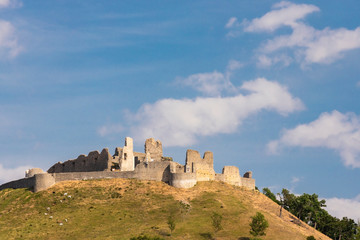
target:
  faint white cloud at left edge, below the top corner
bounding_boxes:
[0,20,22,58]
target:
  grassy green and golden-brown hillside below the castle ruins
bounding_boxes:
[0,179,330,240]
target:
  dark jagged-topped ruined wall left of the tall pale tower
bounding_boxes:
[47,148,112,173]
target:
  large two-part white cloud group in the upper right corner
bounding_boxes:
[226,1,360,67]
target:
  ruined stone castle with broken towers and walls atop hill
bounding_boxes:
[0,137,255,192]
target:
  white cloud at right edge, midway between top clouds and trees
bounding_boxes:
[268,111,360,168]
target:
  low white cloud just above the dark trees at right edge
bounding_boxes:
[325,195,360,222]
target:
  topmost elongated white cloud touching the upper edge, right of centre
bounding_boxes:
[244,1,319,32]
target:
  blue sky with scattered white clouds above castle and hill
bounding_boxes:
[0,0,360,220]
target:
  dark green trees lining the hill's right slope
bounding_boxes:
[263,188,360,240]
